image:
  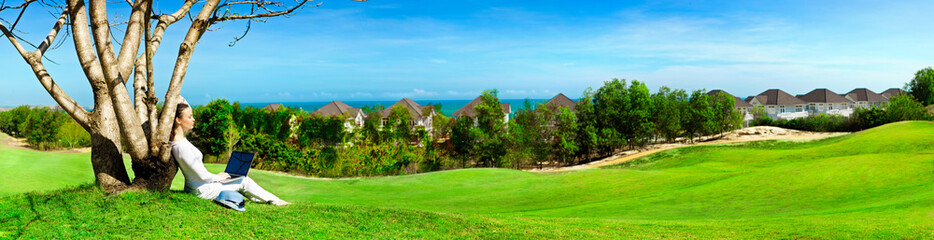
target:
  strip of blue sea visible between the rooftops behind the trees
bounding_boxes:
[240,99,548,116]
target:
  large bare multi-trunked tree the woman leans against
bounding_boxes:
[0,0,344,191]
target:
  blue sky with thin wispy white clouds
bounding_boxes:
[0,0,934,108]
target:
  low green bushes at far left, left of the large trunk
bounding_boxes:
[0,106,91,150]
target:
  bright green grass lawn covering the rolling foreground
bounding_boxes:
[0,122,934,239]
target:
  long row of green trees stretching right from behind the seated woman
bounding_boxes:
[189,79,741,176]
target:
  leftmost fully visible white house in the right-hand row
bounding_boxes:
[746,89,808,119]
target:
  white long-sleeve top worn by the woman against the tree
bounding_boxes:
[172,139,221,199]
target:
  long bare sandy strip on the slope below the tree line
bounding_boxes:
[528,126,849,172]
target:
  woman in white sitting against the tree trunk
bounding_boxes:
[170,99,291,206]
